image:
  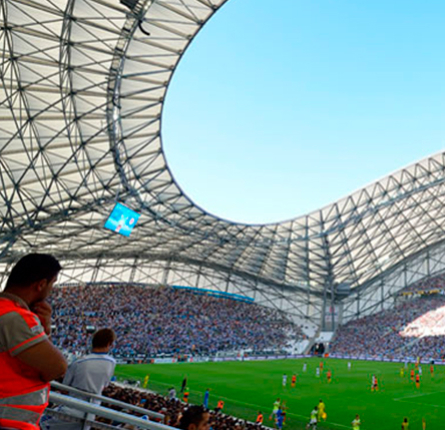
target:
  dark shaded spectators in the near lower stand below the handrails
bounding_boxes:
[102,384,263,430]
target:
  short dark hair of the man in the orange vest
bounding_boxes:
[5,254,62,289]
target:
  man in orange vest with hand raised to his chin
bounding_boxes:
[0,254,67,430]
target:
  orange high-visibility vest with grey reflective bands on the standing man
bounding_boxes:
[0,297,49,430]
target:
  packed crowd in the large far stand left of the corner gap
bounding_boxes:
[51,285,303,357]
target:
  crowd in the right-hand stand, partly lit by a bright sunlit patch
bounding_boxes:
[330,294,445,360]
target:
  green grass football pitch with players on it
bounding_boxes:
[116,358,445,430]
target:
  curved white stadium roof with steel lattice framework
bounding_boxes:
[0,0,445,324]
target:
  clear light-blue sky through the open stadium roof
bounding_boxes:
[163,0,445,223]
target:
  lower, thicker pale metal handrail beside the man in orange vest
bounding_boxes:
[49,392,176,430]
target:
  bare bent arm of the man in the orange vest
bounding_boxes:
[16,339,68,382]
